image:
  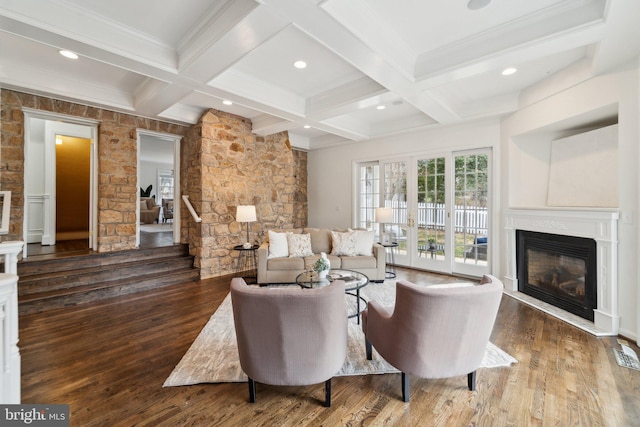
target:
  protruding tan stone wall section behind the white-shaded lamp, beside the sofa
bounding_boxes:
[181,110,307,278]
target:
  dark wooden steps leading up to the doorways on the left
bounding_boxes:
[18,245,200,314]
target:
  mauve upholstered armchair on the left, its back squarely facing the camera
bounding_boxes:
[231,278,347,407]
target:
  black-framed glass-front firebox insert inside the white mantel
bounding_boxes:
[516,230,597,321]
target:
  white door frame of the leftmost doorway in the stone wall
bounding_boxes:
[22,108,100,258]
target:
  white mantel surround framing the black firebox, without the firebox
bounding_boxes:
[504,208,620,335]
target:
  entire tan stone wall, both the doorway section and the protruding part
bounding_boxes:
[0,90,308,278]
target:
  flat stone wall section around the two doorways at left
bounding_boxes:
[0,89,188,252]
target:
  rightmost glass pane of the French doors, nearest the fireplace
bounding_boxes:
[453,152,491,274]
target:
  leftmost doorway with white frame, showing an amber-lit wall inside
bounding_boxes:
[23,108,98,257]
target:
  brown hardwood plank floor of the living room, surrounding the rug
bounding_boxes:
[20,269,640,426]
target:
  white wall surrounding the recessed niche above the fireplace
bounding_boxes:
[500,67,640,340]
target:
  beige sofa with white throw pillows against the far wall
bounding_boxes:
[257,228,386,285]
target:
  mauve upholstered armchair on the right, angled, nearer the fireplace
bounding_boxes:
[362,275,504,402]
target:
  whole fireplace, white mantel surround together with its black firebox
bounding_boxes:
[503,207,620,336]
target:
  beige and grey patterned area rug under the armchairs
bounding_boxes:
[164,281,517,387]
